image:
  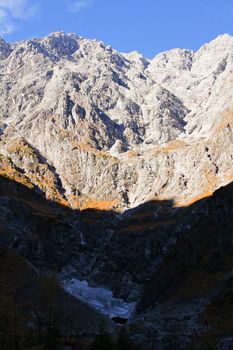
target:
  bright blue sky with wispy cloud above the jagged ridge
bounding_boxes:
[0,0,233,57]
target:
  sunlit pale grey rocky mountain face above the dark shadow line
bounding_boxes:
[0,33,233,209]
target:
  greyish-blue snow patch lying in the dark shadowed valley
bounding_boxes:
[63,278,136,319]
